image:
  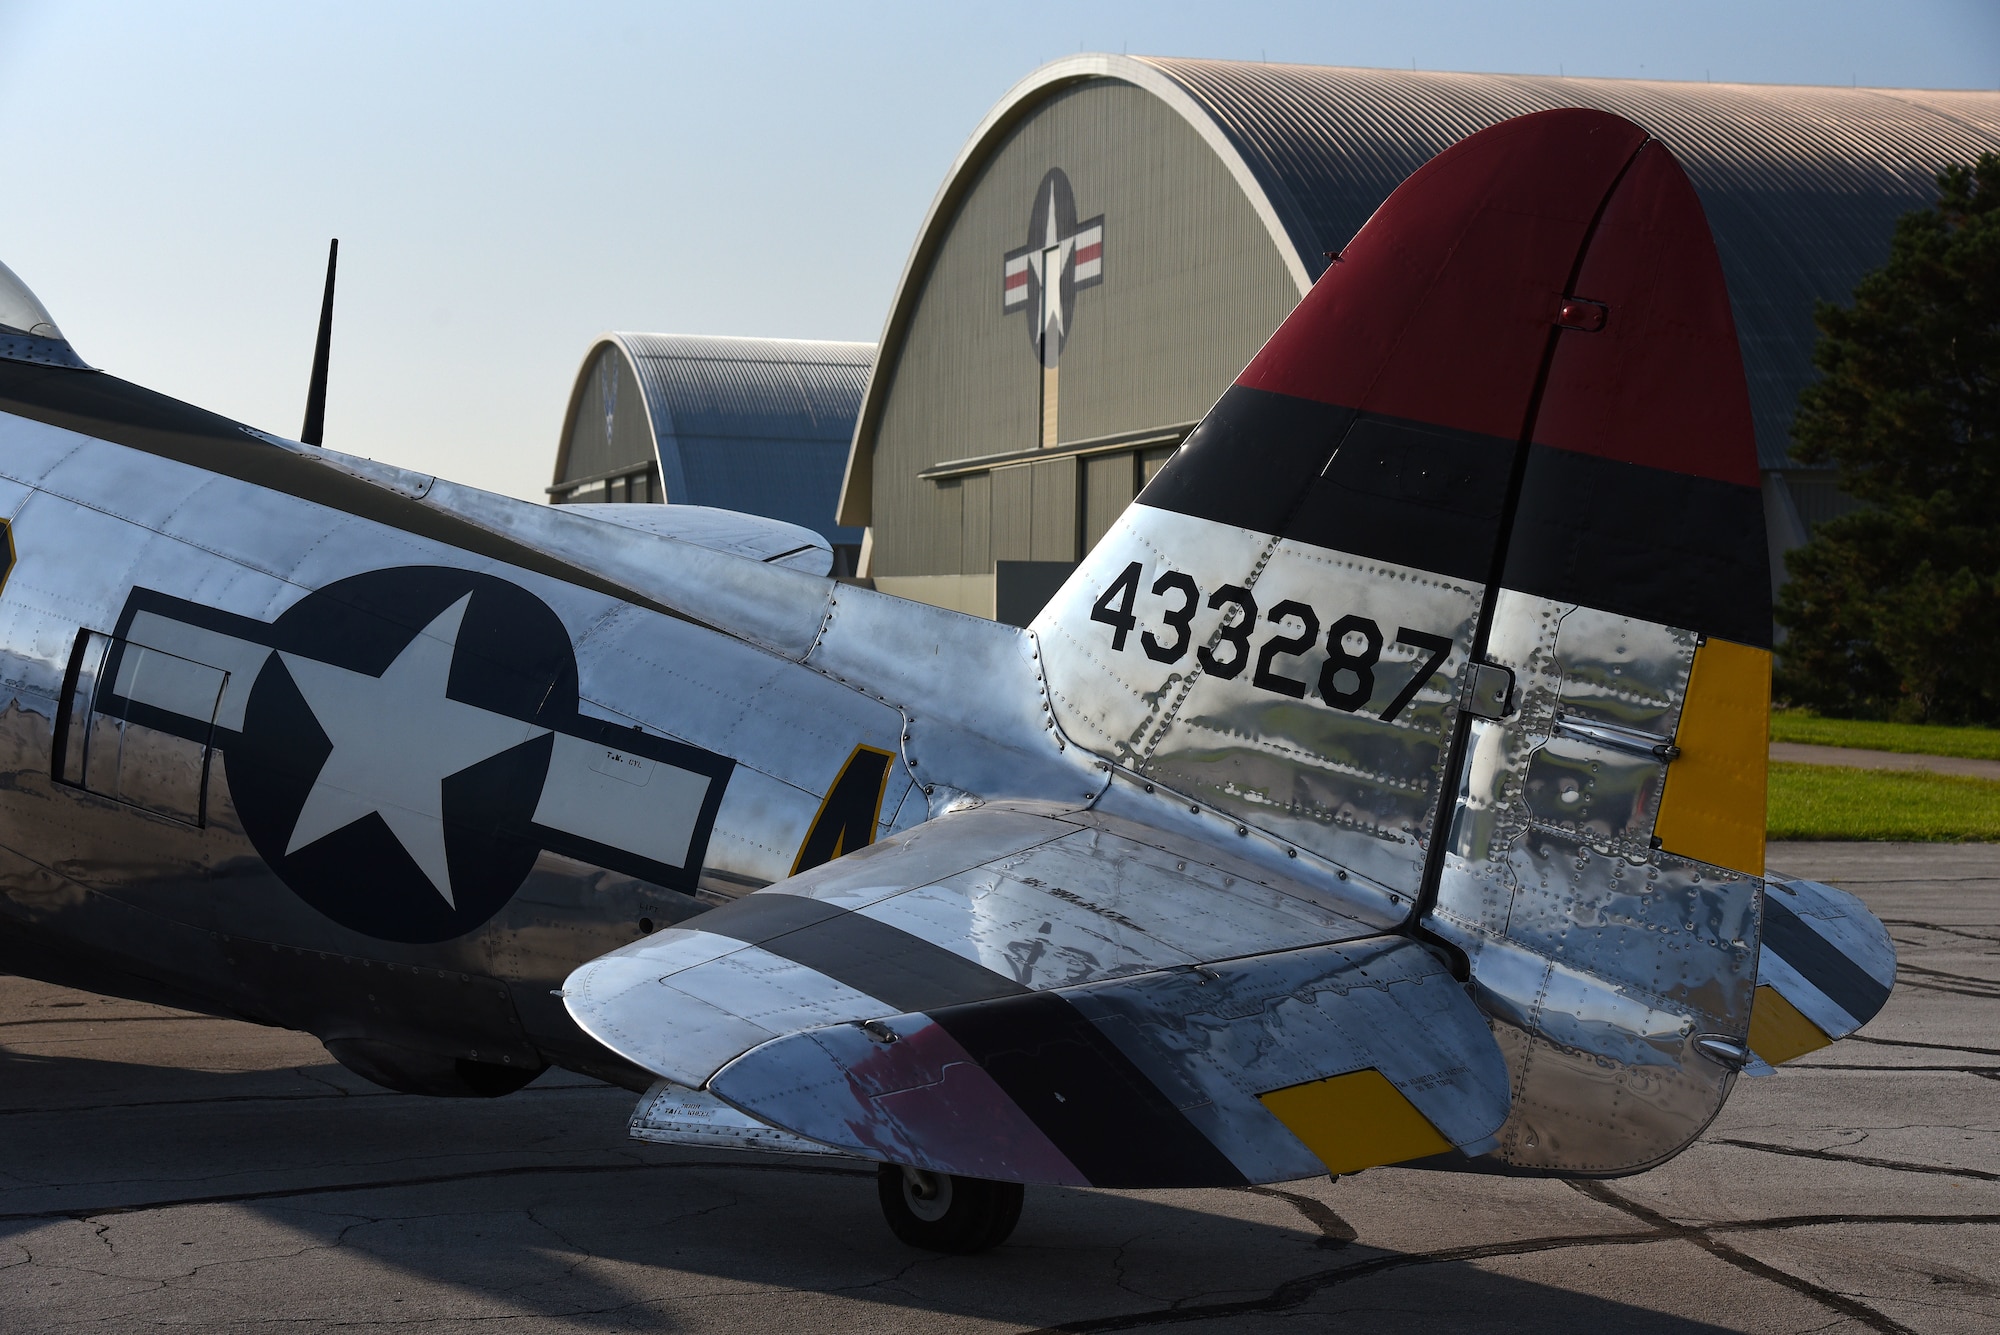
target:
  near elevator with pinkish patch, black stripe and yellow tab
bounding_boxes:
[710,937,1508,1187]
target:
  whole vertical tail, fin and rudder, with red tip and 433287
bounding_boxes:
[1034,110,1770,1173]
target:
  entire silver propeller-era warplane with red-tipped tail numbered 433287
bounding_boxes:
[0,110,1896,1251]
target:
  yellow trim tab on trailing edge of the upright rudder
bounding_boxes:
[1652,640,1770,875]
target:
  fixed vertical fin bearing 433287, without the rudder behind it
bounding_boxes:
[1034,110,1720,893]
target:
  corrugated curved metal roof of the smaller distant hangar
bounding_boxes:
[606,334,874,544]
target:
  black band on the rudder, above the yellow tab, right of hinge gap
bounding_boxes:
[1500,446,1770,650]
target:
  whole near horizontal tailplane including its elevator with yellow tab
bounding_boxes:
[564,805,1508,1187]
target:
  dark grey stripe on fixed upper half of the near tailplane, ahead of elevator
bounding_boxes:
[688,891,1028,1013]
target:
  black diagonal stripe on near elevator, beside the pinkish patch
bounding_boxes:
[930,991,1246,1187]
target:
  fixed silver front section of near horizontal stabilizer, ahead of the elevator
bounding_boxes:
[564,807,1384,1087]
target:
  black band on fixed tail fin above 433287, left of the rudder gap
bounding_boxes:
[1140,386,1514,582]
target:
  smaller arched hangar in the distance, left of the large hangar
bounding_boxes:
[548,334,874,546]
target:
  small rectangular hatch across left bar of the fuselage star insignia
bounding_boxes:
[54,630,230,827]
